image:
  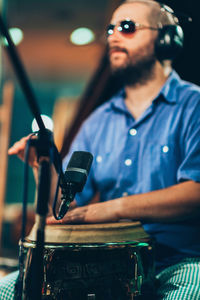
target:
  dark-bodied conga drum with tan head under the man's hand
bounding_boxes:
[23,222,154,300]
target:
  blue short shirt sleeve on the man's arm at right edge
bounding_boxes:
[177,94,200,182]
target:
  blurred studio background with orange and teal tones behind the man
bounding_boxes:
[0,0,200,274]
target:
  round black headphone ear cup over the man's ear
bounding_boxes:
[155,25,184,61]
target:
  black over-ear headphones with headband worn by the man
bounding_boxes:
[155,2,188,61]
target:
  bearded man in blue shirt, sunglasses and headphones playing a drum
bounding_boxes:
[3,0,200,299]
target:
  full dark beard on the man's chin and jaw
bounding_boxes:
[110,50,156,86]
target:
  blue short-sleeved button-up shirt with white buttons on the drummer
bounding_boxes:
[64,71,200,274]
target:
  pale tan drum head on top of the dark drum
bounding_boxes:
[26,222,149,244]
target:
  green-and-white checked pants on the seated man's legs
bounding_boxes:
[0,258,200,300]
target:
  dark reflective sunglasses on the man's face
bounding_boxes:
[106,19,159,37]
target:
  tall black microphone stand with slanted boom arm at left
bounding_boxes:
[0,14,62,300]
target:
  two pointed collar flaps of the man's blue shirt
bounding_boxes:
[110,70,181,112]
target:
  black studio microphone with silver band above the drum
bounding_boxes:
[58,151,93,220]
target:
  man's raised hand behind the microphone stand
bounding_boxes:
[8,134,38,168]
